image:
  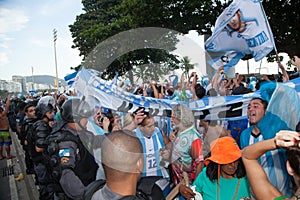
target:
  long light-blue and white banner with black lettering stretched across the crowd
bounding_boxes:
[69,68,300,123]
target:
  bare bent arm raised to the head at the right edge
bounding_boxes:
[243,127,300,200]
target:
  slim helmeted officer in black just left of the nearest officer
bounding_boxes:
[27,96,55,200]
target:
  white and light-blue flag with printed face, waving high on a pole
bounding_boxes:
[205,0,275,71]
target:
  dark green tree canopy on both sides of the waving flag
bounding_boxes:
[70,0,300,79]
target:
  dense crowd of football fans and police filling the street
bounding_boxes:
[0,56,300,200]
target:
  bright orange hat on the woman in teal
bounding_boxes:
[204,137,242,165]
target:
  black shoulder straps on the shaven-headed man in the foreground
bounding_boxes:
[83,179,150,200]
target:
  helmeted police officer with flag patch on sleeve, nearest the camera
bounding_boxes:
[48,98,98,199]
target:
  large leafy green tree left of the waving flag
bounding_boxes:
[70,0,224,79]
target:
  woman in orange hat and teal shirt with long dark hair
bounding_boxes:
[180,136,250,200]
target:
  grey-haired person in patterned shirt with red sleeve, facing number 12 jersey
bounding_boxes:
[167,104,204,185]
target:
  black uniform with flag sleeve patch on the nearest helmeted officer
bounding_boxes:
[48,121,98,199]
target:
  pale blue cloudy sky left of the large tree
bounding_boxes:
[0,0,83,80]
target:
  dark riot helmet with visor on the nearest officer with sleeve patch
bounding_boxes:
[61,98,93,123]
